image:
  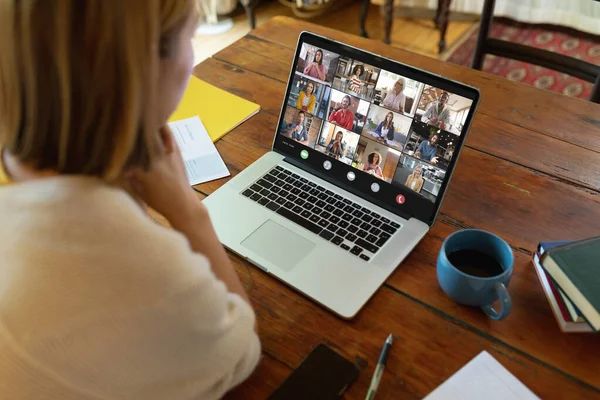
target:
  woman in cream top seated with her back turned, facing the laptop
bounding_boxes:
[0,0,260,400]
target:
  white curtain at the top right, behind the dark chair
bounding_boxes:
[397,0,600,35]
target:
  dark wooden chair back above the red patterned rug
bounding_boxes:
[471,0,600,103]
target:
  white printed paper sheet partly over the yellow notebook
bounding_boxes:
[169,116,230,185]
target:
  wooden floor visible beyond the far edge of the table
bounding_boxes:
[194,0,474,63]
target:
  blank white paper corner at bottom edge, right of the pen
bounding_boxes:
[424,351,539,400]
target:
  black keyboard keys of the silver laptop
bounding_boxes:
[242,166,400,261]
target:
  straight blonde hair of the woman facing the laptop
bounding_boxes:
[0,0,195,180]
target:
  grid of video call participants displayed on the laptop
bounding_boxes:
[280,43,473,202]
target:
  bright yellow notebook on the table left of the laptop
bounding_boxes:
[169,76,260,142]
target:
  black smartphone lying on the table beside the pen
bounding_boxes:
[269,344,358,400]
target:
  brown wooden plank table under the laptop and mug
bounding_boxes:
[189,18,600,399]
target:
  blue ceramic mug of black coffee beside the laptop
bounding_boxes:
[437,229,514,320]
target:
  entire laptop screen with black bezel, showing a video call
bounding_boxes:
[275,33,478,225]
